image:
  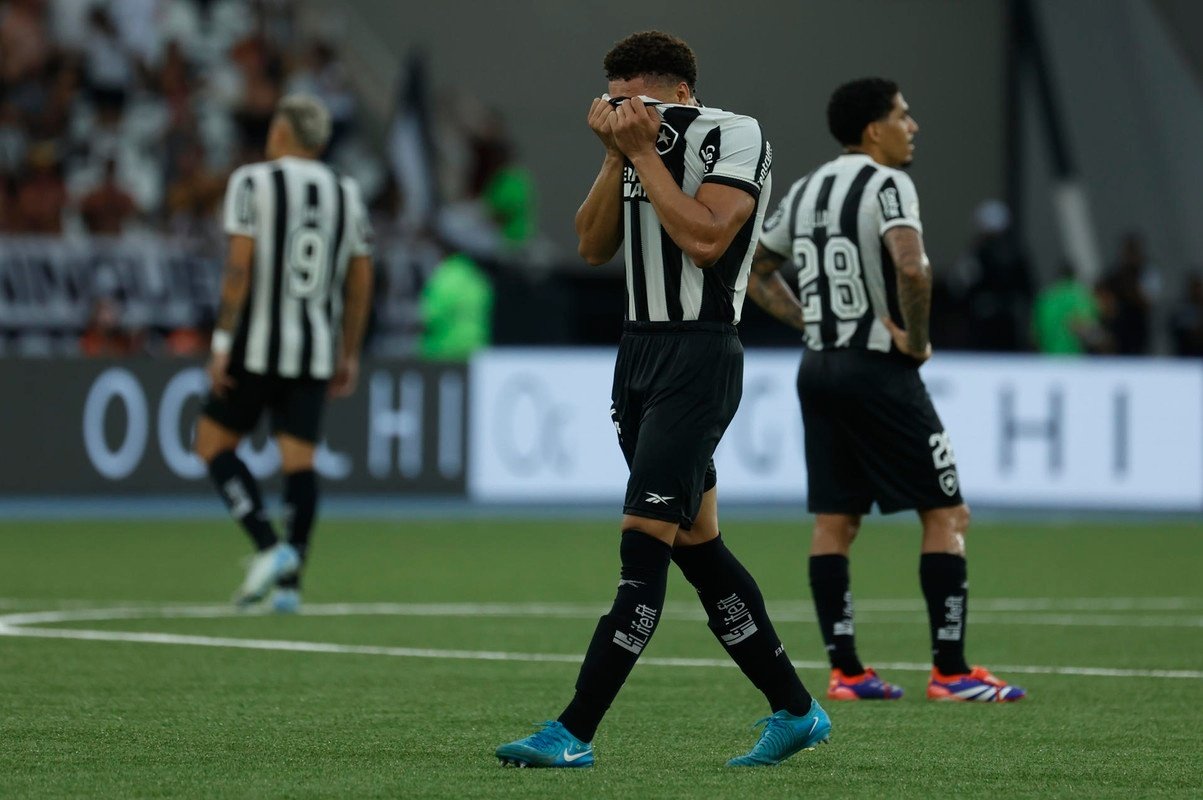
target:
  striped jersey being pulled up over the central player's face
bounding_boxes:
[622,103,772,324]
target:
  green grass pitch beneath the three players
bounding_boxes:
[0,517,1203,800]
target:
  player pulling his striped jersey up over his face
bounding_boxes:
[497,31,831,768]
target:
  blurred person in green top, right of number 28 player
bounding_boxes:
[1032,263,1110,355]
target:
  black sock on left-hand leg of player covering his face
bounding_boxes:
[559,529,672,742]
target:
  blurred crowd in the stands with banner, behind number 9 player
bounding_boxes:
[0,0,533,355]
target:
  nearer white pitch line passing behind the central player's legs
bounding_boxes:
[0,623,1203,681]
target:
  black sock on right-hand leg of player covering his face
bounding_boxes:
[672,535,811,716]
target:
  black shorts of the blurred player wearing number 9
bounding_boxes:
[201,367,327,444]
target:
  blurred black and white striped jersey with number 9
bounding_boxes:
[225,158,372,379]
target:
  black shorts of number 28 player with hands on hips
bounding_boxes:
[798,350,962,514]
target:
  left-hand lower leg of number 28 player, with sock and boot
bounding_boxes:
[808,514,902,700]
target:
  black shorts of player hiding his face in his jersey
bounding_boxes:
[610,322,743,528]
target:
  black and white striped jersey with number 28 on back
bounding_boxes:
[760,153,923,352]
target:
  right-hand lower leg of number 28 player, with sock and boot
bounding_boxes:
[919,503,1026,703]
